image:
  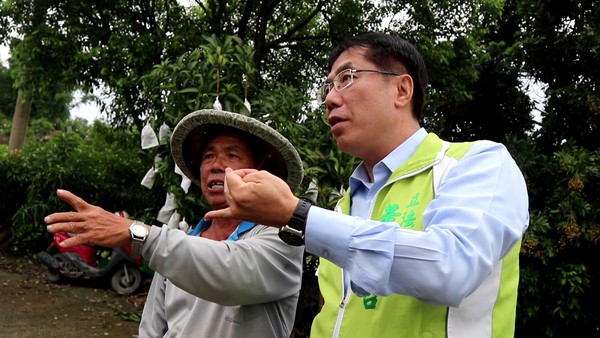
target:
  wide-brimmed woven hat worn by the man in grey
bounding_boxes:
[171,109,304,191]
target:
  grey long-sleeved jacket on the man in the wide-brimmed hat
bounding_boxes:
[139,225,304,338]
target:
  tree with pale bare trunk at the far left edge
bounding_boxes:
[0,1,81,150]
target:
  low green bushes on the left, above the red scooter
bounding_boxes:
[0,121,164,255]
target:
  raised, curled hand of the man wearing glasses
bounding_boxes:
[204,168,298,227]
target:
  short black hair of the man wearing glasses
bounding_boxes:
[328,32,429,120]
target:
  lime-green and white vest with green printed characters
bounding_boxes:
[311,133,520,338]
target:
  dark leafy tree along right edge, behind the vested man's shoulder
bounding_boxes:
[511,0,600,337]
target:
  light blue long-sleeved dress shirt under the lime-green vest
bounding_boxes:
[305,128,529,306]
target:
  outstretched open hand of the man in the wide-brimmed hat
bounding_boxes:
[44,189,132,248]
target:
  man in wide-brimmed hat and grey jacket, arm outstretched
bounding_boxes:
[46,110,303,338]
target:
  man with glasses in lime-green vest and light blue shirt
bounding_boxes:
[206,33,529,338]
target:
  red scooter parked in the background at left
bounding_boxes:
[38,213,148,295]
